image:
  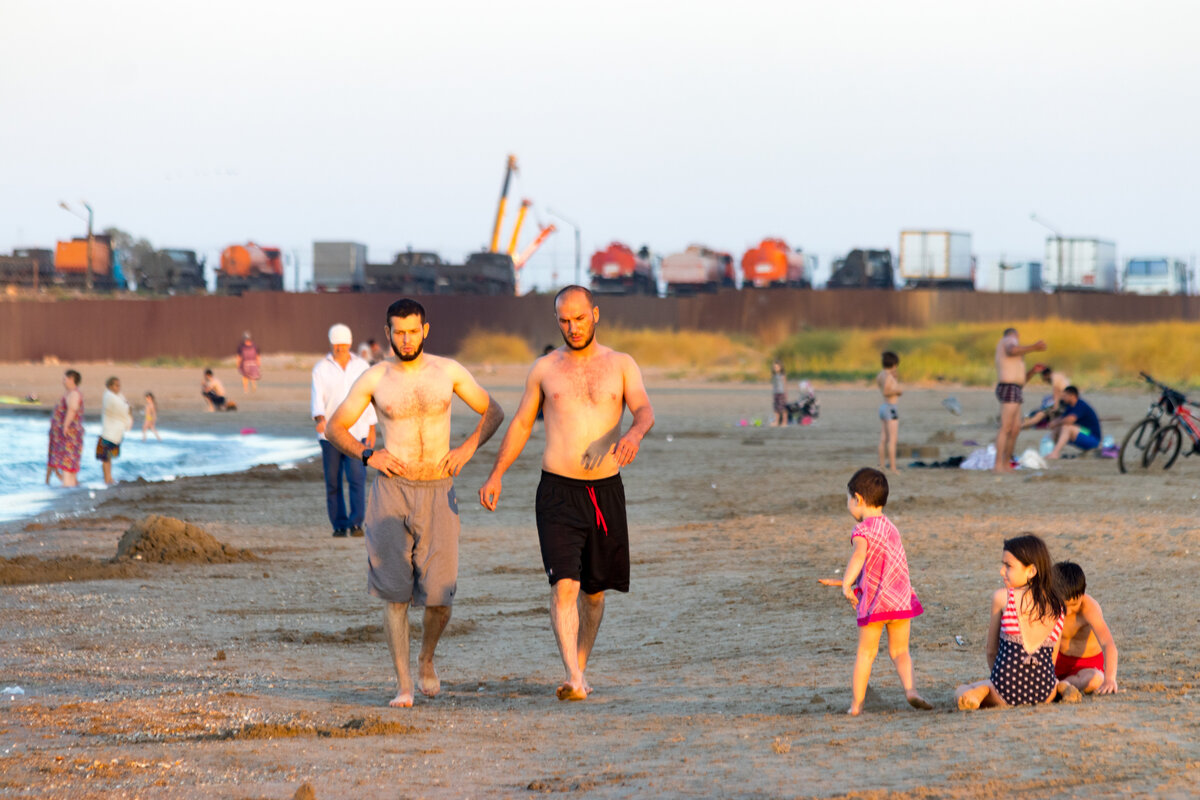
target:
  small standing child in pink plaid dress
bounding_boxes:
[821,467,934,716]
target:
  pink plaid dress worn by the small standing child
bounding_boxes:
[850,515,925,626]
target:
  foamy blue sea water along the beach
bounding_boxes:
[0,415,320,521]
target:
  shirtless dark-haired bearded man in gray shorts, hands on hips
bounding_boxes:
[325,300,504,708]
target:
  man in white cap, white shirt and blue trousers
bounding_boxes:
[312,323,376,536]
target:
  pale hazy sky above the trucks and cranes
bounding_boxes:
[0,0,1200,288]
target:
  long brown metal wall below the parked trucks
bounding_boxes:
[0,289,1200,361]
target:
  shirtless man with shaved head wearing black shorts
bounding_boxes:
[479,287,654,700]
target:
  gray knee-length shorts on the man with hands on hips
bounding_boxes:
[364,475,458,606]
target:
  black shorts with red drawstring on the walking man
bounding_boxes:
[534,470,629,595]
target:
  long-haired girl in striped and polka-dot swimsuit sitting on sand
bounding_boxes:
[954,535,1080,710]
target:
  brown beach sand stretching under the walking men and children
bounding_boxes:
[0,356,1200,799]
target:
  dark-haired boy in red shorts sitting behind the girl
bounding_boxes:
[1054,561,1117,694]
